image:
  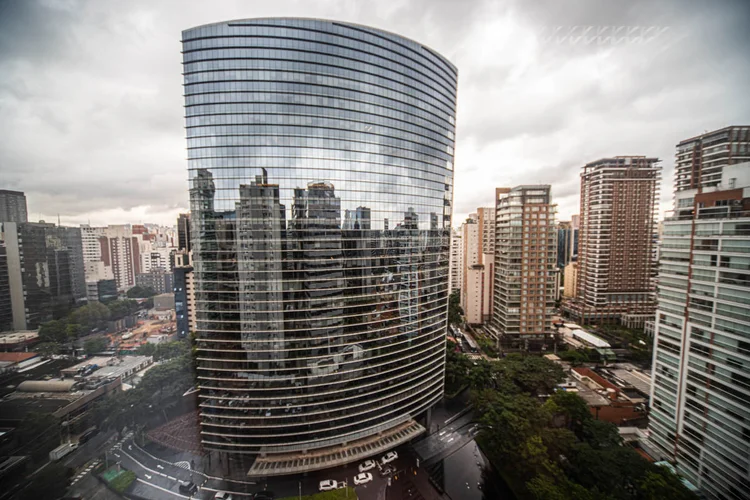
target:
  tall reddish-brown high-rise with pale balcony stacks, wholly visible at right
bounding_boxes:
[563,156,661,327]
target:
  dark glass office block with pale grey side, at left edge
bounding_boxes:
[2,222,74,330]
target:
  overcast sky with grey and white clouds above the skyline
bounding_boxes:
[0,0,750,224]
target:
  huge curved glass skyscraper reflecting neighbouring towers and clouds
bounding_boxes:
[182,19,456,475]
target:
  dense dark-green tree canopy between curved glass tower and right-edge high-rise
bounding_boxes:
[446,347,697,500]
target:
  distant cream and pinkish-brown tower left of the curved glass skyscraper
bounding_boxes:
[99,225,142,292]
